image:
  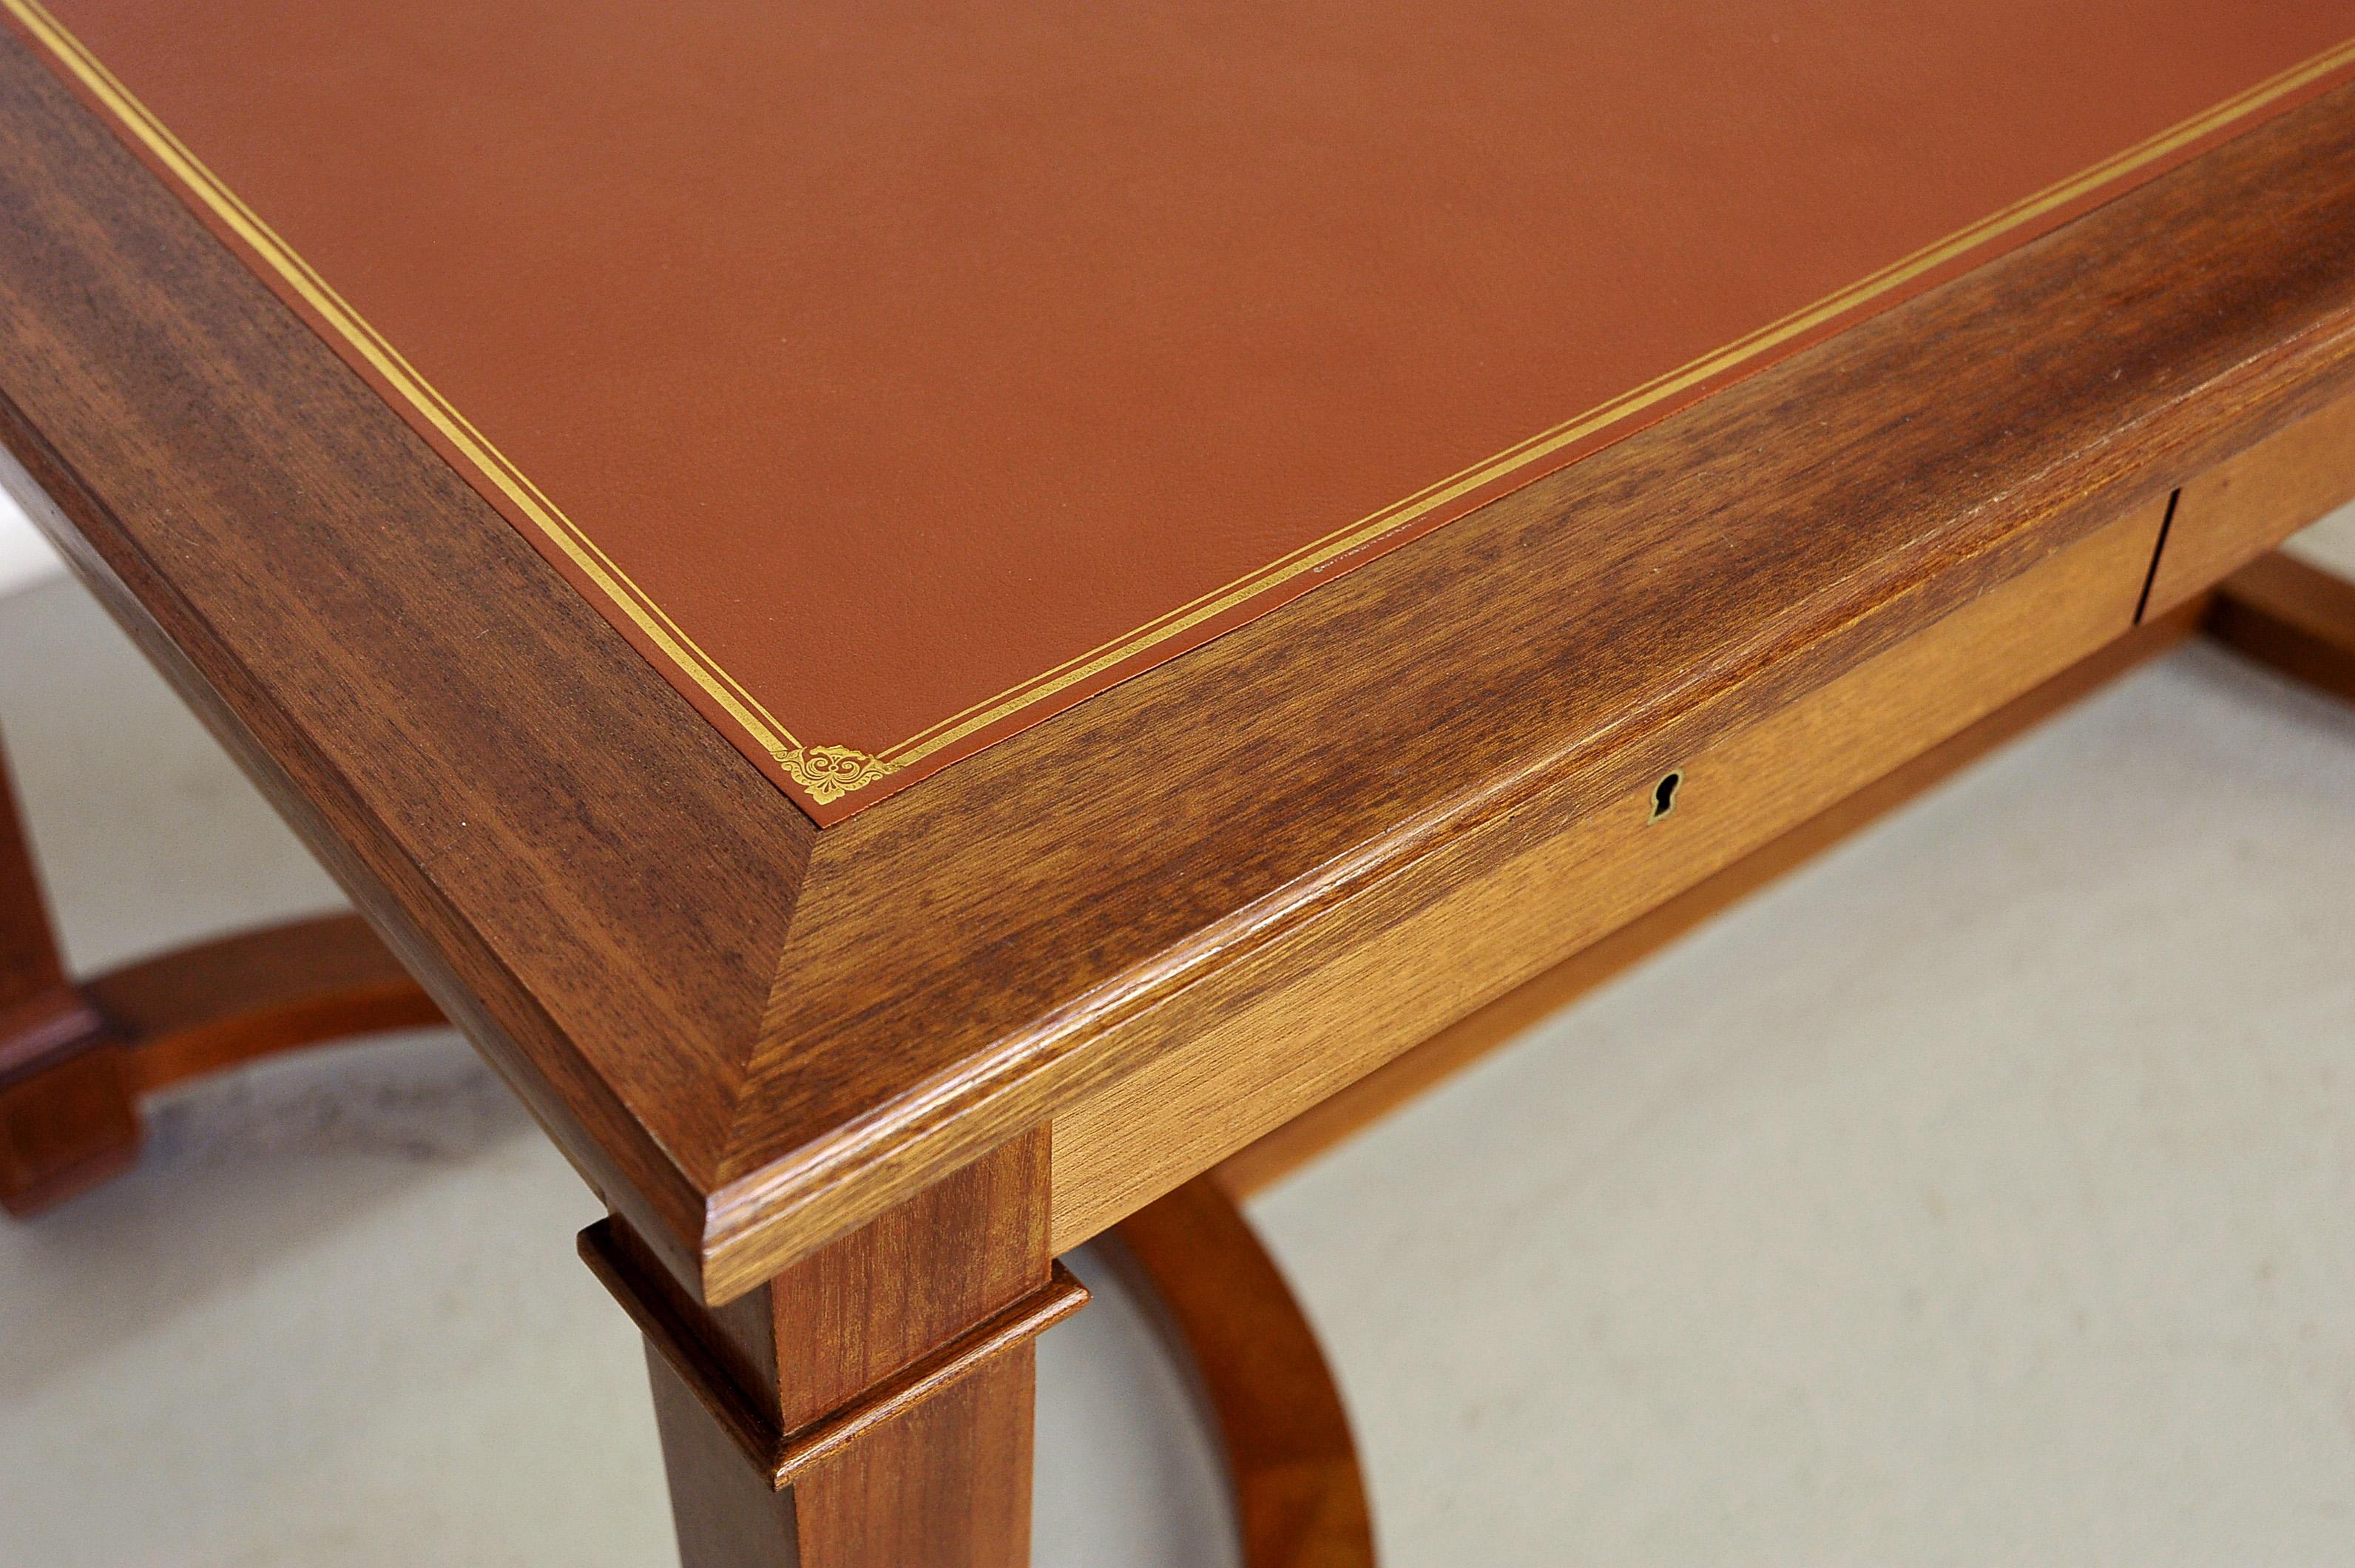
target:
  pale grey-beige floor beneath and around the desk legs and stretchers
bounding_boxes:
[0,513,2355,1568]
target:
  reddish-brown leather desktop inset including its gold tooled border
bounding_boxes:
[0,0,2355,822]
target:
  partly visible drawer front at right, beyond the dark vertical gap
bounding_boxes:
[2143,398,2355,619]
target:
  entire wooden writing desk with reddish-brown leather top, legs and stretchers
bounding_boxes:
[13,0,2355,1568]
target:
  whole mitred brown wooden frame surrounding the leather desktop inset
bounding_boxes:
[0,21,2355,1300]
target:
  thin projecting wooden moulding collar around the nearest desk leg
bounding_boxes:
[579,1217,1088,1490]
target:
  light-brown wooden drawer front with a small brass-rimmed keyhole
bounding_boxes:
[1053,499,2166,1252]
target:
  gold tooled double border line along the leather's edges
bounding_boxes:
[18,0,2355,805]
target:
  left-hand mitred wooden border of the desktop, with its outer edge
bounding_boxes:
[0,38,812,1271]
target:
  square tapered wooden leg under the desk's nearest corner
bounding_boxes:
[581,1128,1086,1568]
